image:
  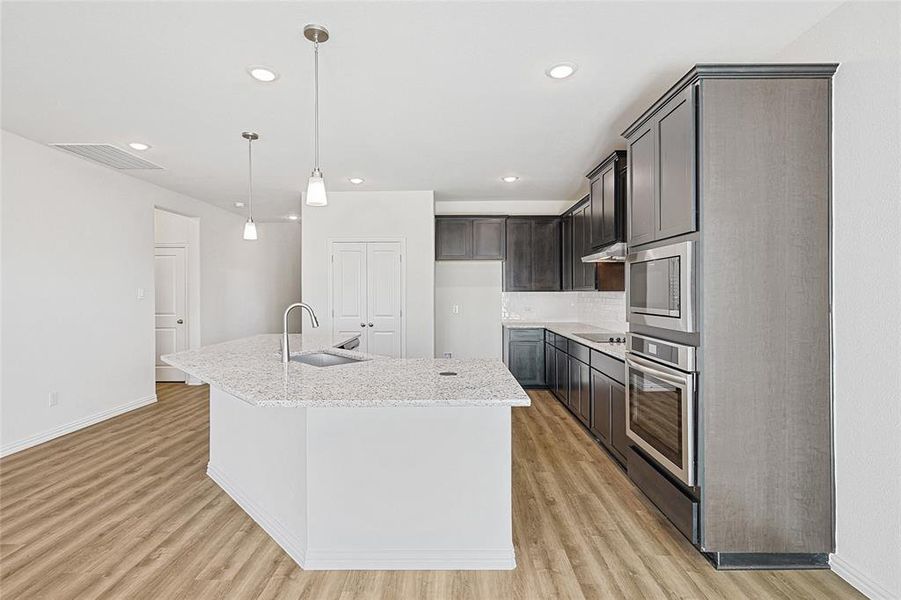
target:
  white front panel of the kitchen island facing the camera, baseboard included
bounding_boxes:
[304,407,515,569]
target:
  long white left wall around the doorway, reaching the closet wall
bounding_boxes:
[0,131,300,454]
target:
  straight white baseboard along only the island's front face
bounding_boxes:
[303,548,516,571]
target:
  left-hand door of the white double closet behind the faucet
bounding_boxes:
[331,243,368,352]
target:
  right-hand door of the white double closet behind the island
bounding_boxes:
[366,242,401,358]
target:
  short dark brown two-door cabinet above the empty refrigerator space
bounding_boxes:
[435,217,506,260]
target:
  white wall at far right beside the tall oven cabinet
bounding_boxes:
[772,2,901,598]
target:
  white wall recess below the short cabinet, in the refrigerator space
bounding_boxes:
[435,260,503,359]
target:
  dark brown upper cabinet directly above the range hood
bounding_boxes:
[586,150,626,250]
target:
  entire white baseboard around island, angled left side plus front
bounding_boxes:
[206,464,516,571]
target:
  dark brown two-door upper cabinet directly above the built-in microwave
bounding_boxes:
[625,85,697,246]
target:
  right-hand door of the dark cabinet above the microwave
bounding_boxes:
[655,86,696,240]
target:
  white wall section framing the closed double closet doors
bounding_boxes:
[301,191,435,357]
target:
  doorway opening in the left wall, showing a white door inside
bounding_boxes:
[153,208,200,384]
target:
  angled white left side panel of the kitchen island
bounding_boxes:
[207,386,307,566]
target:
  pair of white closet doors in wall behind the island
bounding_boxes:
[330,242,405,358]
